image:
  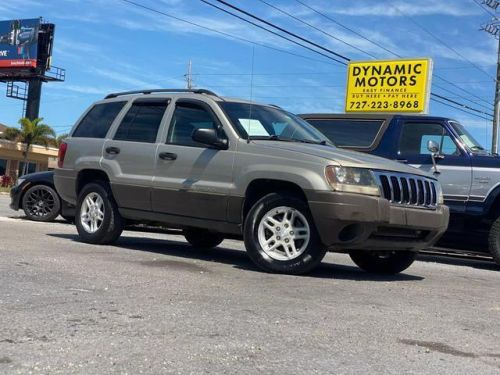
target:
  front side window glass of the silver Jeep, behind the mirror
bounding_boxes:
[167,102,217,148]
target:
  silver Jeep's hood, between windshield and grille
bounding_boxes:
[254,141,435,179]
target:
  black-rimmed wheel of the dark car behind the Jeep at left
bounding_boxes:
[22,185,61,222]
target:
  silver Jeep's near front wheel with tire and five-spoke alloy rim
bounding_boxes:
[243,192,326,275]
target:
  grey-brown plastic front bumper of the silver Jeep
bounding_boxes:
[307,192,449,251]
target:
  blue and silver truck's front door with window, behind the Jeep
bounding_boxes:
[398,121,472,211]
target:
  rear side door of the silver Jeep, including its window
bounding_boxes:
[101,98,169,211]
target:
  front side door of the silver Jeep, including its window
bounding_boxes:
[152,99,235,221]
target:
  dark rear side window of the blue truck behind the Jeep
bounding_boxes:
[307,119,384,148]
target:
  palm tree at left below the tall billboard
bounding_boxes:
[5,117,56,175]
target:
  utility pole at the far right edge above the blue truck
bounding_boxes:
[481,0,500,154]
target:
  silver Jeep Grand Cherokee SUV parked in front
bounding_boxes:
[55,89,449,274]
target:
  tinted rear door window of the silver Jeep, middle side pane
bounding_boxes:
[113,99,168,143]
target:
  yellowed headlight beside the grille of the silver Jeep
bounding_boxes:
[325,165,380,196]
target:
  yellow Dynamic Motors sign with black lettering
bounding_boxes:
[345,58,432,113]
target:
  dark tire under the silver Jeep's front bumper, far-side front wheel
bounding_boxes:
[349,250,418,275]
